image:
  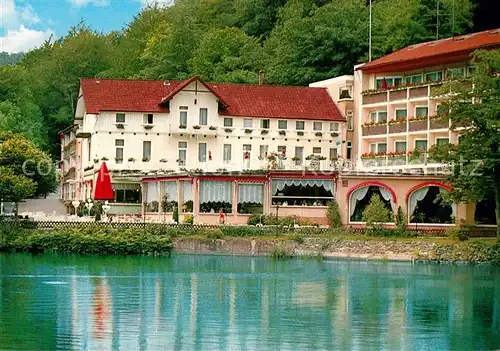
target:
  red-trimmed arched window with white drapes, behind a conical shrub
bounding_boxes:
[349,185,395,222]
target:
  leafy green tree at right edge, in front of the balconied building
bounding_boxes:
[430,50,500,240]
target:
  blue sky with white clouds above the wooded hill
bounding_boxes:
[0,0,169,53]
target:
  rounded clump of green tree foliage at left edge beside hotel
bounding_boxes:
[0,133,57,202]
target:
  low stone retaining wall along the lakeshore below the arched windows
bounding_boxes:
[174,236,496,262]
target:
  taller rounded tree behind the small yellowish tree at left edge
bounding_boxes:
[0,132,57,196]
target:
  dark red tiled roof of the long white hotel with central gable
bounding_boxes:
[80,77,345,121]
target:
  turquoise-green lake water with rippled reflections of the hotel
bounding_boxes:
[0,254,500,350]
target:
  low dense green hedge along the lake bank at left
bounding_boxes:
[0,226,172,255]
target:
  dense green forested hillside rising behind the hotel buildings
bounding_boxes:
[0,0,473,154]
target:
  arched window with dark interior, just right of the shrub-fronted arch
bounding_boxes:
[408,185,456,224]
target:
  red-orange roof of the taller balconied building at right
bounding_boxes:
[359,28,500,73]
